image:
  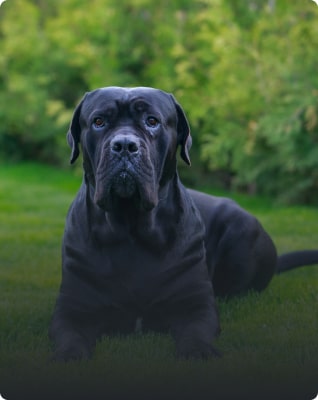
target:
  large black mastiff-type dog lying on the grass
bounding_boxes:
[50,87,318,360]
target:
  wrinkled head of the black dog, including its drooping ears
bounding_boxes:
[68,87,191,212]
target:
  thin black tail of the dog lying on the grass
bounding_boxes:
[276,250,318,274]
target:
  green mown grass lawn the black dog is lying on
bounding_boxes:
[0,164,318,400]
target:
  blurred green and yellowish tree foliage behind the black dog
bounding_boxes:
[0,0,318,204]
